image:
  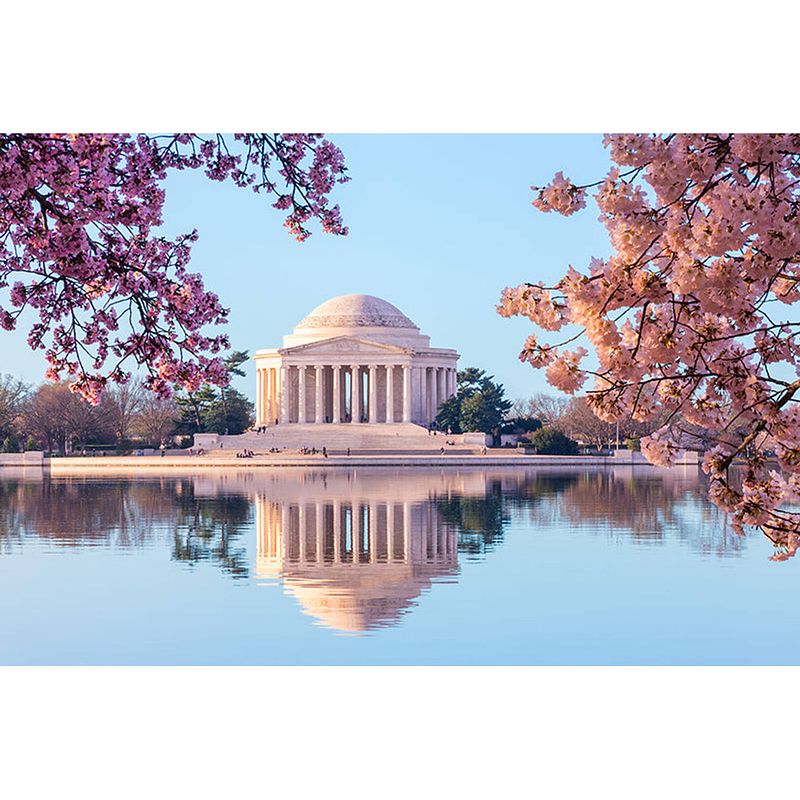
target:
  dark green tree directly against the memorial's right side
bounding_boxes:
[436,367,511,440]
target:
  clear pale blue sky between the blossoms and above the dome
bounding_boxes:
[0,134,610,400]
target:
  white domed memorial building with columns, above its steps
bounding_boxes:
[255,295,458,426]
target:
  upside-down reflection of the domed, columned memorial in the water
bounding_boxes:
[256,496,458,632]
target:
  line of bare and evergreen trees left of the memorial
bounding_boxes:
[0,351,254,453]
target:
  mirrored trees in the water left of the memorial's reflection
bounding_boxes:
[0,478,252,577]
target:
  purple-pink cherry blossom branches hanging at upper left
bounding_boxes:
[0,133,349,403]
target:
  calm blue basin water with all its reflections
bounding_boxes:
[0,467,800,664]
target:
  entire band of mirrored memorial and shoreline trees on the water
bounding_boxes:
[0,467,745,632]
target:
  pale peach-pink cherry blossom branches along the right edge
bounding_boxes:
[497,134,800,560]
